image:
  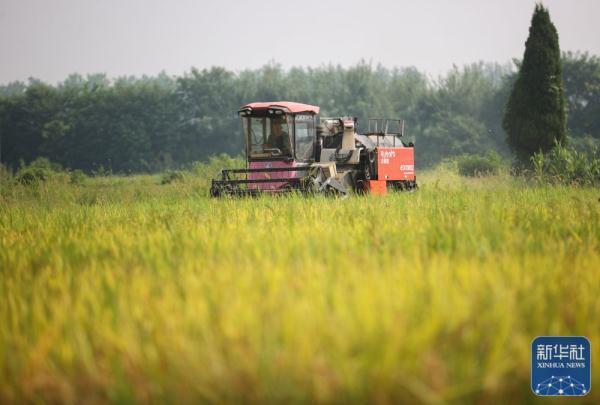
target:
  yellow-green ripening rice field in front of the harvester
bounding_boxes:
[0,172,600,403]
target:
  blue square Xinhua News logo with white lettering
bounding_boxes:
[531,336,592,396]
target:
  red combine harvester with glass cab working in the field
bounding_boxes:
[210,101,417,197]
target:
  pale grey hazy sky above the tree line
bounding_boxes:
[0,0,600,84]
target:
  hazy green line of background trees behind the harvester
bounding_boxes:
[0,53,600,173]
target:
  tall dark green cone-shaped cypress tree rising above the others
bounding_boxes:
[503,4,567,162]
